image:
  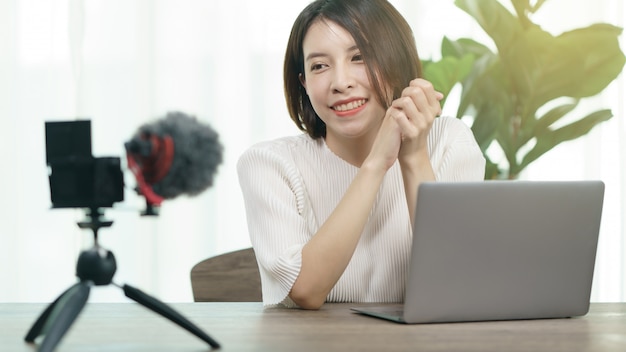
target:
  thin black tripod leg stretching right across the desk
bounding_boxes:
[122,285,220,348]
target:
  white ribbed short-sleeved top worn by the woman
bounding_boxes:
[237,117,485,306]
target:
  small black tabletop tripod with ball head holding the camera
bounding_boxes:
[24,208,220,352]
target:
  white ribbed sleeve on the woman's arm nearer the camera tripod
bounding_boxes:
[237,147,311,307]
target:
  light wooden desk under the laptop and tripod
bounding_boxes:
[0,303,626,352]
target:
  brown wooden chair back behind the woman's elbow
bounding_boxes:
[191,248,262,302]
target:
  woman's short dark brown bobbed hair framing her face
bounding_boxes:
[283,0,422,139]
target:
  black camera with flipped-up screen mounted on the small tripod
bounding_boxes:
[46,120,124,209]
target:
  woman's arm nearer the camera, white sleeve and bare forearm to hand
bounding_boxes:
[238,136,400,309]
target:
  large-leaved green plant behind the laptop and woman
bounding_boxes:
[423,0,625,179]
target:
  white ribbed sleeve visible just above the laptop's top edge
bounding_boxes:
[429,117,486,182]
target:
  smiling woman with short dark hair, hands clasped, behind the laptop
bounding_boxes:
[238,0,485,309]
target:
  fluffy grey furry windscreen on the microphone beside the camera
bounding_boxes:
[131,112,223,199]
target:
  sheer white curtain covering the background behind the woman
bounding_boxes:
[0,0,626,302]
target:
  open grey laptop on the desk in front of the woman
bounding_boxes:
[352,181,604,324]
